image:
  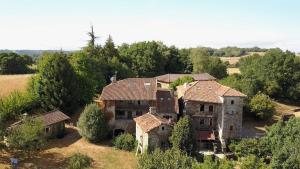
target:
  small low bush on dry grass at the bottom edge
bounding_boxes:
[66,153,92,169]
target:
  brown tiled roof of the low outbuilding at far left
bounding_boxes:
[41,110,70,126]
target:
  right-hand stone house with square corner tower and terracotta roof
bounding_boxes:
[182,80,246,151]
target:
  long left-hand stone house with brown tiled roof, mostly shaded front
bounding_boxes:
[95,78,178,136]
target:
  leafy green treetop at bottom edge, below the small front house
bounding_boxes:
[138,149,195,169]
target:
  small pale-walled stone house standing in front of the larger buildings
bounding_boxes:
[134,111,172,153]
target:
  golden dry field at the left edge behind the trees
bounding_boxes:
[0,74,32,98]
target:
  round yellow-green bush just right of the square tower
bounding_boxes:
[250,93,275,120]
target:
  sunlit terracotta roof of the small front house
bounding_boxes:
[133,113,170,133]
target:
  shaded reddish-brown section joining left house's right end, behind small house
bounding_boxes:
[156,89,179,113]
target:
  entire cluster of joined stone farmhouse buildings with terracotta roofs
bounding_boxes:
[96,73,246,152]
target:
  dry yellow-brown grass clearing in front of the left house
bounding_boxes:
[0,110,137,169]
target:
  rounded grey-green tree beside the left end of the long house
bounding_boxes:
[77,103,109,142]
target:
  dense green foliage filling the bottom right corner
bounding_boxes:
[229,118,300,169]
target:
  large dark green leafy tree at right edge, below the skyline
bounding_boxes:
[239,49,300,100]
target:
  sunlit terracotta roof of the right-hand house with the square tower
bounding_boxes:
[183,81,246,103]
